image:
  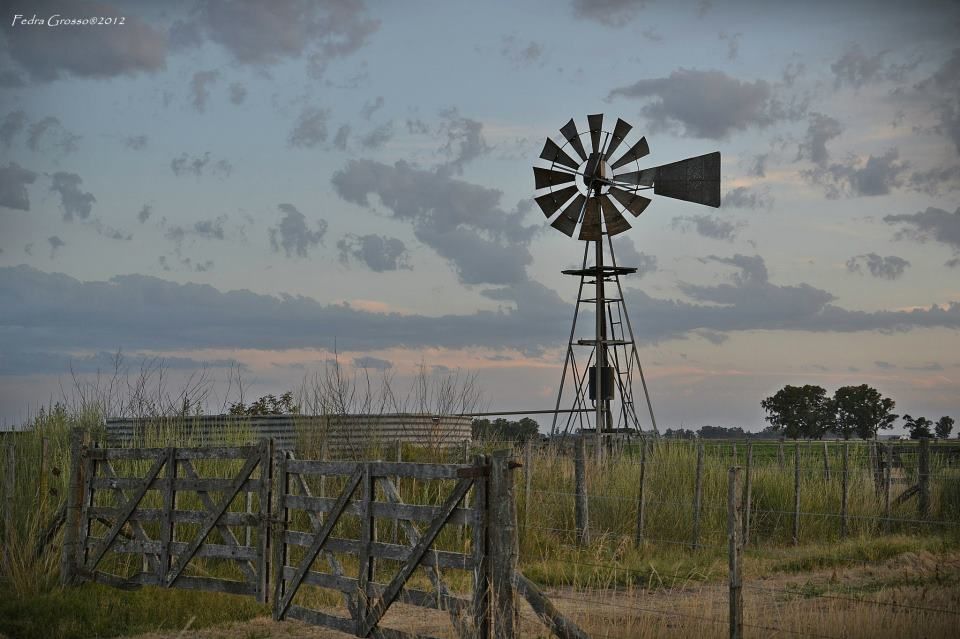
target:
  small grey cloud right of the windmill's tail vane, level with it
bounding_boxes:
[801,148,910,199]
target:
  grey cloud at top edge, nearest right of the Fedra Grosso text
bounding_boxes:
[195,0,380,72]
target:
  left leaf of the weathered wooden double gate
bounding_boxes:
[64,440,272,601]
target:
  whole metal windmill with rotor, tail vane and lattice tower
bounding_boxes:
[533,114,720,444]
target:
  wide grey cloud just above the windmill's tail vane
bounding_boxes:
[607,68,804,140]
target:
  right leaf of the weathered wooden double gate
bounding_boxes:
[273,453,489,638]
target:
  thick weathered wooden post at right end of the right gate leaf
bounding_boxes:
[488,450,519,639]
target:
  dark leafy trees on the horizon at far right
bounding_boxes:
[760,384,954,439]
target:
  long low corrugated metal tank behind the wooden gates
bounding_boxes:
[106,413,472,454]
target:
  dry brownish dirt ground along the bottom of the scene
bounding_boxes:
[129,552,960,639]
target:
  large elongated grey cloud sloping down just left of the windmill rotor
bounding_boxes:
[332,160,539,284]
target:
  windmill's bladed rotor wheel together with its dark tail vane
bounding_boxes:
[533,114,720,241]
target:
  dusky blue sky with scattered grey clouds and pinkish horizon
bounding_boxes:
[0,0,960,430]
